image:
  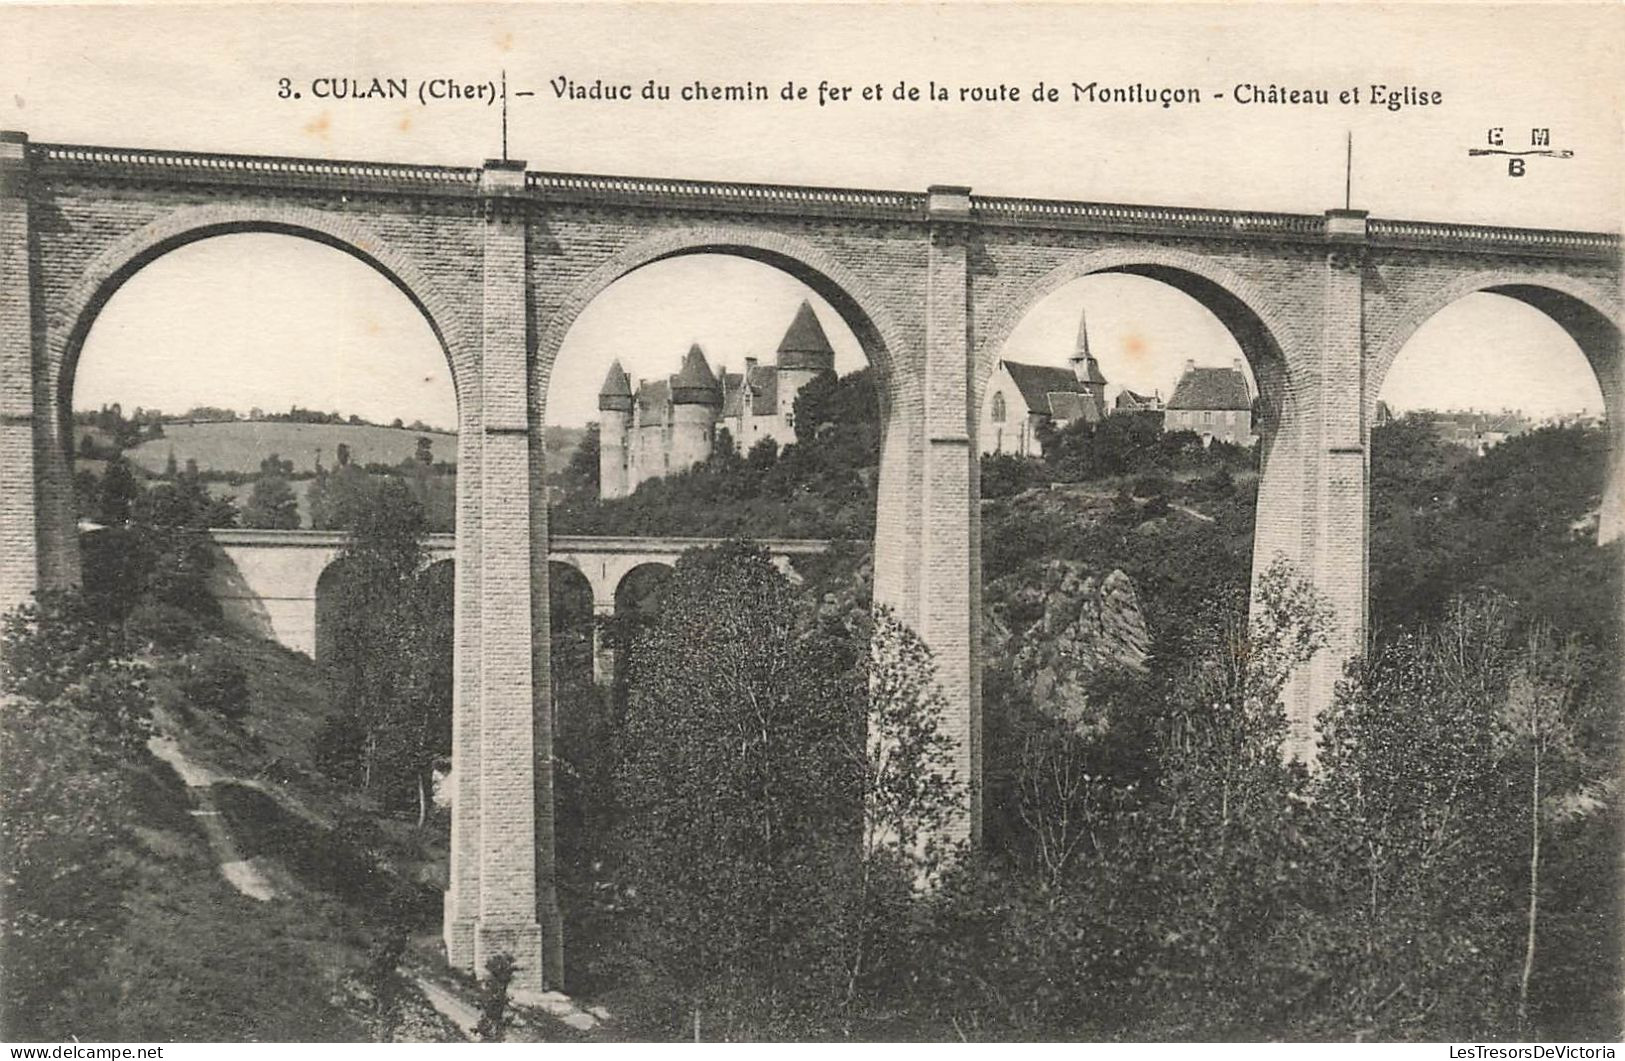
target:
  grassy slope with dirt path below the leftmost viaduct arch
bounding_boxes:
[77,639,460,1042]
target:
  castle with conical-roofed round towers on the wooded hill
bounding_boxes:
[598,302,835,499]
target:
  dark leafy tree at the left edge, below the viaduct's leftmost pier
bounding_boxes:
[0,593,153,1040]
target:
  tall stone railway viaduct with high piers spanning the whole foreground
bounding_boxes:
[0,133,1625,985]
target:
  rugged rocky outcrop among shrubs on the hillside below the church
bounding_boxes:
[983,561,1151,725]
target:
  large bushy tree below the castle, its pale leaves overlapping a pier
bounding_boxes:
[616,544,951,1035]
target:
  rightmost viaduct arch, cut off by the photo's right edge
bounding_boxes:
[1365,270,1625,425]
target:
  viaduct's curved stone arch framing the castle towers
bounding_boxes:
[533,224,918,419]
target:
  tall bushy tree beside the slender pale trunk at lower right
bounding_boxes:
[1313,598,1528,1038]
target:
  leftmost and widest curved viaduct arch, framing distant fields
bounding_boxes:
[47,203,473,441]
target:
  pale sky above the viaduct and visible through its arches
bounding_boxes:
[19,3,1625,424]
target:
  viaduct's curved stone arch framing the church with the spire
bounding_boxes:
[972,245,1292,428]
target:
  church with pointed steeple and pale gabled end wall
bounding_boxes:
[980,305,1107,457]
